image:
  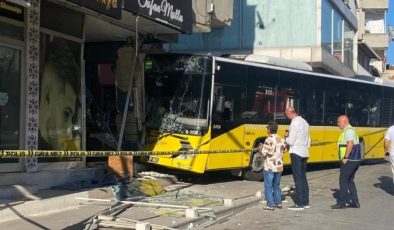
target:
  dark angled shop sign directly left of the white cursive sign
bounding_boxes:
[68,0,123,19]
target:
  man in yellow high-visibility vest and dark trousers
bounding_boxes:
[331,115,361,209]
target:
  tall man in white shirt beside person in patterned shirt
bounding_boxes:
[285,107,311,210]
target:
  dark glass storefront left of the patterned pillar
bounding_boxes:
[0,0,26,172]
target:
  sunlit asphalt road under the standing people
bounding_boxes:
[197,162,394,230]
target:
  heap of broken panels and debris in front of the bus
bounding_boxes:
[77,172,260,230]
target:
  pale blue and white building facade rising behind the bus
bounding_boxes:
[168,0,387,77]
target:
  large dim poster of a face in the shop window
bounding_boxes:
[38,34,81,153]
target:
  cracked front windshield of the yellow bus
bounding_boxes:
[160,56,211,135]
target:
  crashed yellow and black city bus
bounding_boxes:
[145,54,394,180]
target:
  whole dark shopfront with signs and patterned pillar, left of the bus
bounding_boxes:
[0,0,192,173]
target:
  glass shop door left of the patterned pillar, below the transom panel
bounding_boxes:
[0,42,22,173]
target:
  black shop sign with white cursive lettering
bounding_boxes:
[124,0,193,34]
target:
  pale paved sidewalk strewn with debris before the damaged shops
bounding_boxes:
[0,173,276,229]
